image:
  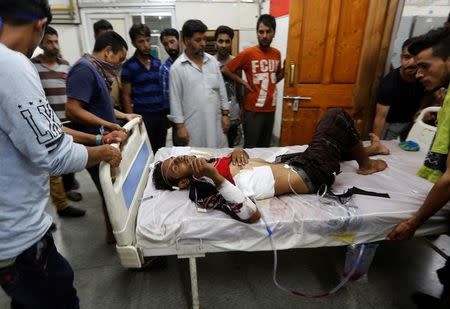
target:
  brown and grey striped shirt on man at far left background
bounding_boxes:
[31,55,70,122]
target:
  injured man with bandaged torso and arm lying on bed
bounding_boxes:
[153,109,389,223]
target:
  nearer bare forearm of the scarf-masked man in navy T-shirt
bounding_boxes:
[66,98,122,131]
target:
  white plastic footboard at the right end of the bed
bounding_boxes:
[406,106,440,152]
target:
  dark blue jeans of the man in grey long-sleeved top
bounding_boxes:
[0,232,79,309]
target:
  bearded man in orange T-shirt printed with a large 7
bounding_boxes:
[222,14,284,148]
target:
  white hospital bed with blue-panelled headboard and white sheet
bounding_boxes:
[100,115,449,308]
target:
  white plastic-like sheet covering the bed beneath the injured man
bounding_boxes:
[136,142,450,251]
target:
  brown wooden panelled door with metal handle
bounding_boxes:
[280,0,398,145]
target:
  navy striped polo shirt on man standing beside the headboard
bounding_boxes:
[121,55,165,114]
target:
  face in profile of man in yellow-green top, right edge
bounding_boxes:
[416,47,450,91]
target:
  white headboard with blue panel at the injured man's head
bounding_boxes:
[100,118,153,267]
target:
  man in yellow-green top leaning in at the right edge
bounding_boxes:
[387,27,450,309]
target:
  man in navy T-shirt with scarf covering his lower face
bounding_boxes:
[66,31,138,243]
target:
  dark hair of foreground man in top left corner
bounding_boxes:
[0,0,52,26]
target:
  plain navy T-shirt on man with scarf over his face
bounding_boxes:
[67,58,116,134]
